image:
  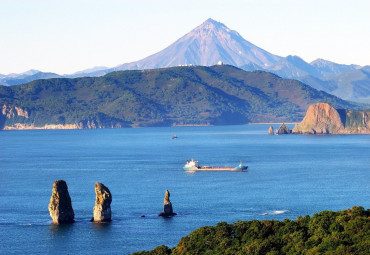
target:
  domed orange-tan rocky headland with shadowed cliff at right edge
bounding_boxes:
[293,103,370,134]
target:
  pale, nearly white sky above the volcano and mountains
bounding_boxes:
[0,0,370,74]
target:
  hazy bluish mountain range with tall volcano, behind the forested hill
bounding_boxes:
[0,19,370,103]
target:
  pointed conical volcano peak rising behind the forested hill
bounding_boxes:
[116,19,281,70]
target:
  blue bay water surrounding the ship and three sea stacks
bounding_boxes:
[0,125,370,254]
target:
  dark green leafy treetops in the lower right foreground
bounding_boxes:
[134,207,370,255]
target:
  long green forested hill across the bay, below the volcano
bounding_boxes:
[0,65,361,129]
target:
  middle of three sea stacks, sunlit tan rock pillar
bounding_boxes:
[91,182,112,222]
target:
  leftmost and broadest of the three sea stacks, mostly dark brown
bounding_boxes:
[49,180,75,224]
